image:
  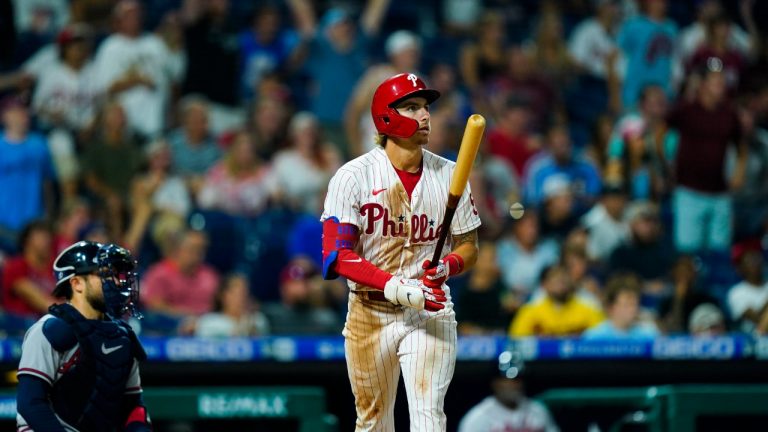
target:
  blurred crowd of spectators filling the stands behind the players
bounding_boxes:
[0,0,768,338]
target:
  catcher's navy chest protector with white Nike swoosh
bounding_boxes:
[49,304,146,432]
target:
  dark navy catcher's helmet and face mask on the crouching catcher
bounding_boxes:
[53,241,139,318]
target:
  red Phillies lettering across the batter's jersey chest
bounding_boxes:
[360,203,443,243]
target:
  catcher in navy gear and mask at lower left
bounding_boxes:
[16,241,151,432]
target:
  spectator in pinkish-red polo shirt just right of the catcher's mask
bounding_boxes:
[141,230,219,317]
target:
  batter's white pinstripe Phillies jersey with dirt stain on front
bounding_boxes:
[321,147,480,290]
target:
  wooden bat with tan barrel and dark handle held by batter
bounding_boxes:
[429,114,485,268]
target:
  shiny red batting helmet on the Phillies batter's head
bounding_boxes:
[371,73,440,138]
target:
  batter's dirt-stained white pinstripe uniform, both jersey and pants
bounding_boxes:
[321,148,480,431]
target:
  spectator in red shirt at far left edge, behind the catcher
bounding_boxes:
[0,222,56,317]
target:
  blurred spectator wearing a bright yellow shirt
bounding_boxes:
[509,264,605,338]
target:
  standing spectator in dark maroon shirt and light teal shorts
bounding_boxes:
[667,62,747,253]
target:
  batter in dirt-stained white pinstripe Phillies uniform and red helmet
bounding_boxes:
[321,74,480,432]
